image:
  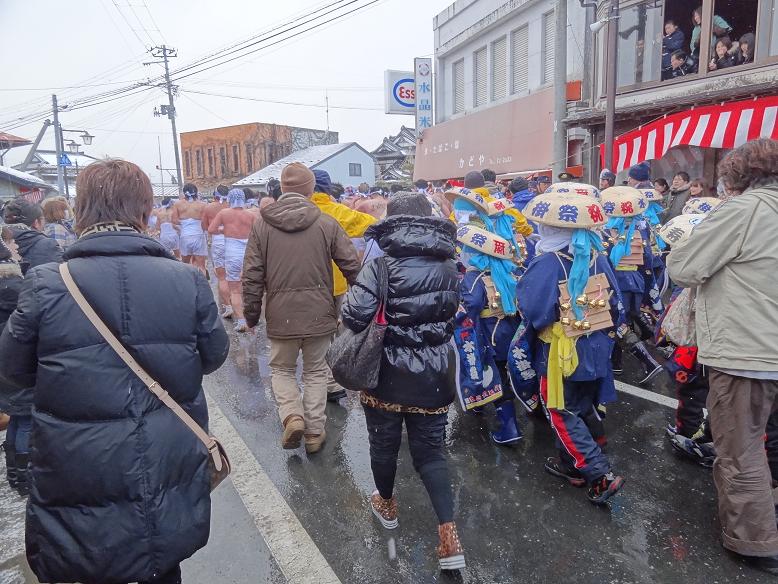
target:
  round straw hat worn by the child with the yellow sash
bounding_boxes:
[524,192,607,229]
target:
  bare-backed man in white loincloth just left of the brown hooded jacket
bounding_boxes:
[208,189,255,333]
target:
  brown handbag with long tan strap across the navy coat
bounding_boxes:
[59,263,232,491]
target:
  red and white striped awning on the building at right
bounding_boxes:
[600,96,778,172]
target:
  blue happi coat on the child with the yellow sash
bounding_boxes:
[519,252,625,403]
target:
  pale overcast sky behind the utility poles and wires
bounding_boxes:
[0,0,453,182]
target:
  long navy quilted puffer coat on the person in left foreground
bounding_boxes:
[0,232,229,583]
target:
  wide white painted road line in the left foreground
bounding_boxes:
[208,396,341,584]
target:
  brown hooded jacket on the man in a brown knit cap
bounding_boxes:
[243,193,360,339]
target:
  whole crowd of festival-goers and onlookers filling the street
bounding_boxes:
[0,139,778,584]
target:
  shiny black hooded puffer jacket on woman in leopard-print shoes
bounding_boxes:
[342,215,459,408]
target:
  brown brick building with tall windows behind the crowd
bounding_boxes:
[181,122,338,193]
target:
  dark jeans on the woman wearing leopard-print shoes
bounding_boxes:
[363,406,454,524]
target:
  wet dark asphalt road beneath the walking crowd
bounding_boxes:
[0,326,771,584]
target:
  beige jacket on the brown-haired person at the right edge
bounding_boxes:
[667,183,778,371]
